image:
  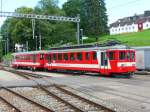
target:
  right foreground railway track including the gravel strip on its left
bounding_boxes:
[10,85,114,112]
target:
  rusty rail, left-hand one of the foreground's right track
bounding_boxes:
[39,85,84,112]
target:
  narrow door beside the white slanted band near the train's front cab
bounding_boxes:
[101,52,108,74]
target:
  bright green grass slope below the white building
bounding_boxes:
[85,29,150,46]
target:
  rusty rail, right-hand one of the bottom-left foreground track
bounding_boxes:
[3,87,54,112]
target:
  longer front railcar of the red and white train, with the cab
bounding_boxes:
[45,46,136,76]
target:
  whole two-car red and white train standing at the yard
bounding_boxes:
[12,46,136,76]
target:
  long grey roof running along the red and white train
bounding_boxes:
[13,42,134,55]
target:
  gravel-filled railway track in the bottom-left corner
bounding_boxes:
[0,87,54,112]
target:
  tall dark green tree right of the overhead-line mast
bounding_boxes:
[81,0,108,36]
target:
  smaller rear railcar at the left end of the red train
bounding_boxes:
[12,51,46,70]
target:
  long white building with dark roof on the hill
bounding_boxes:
[109,11,150,35]
